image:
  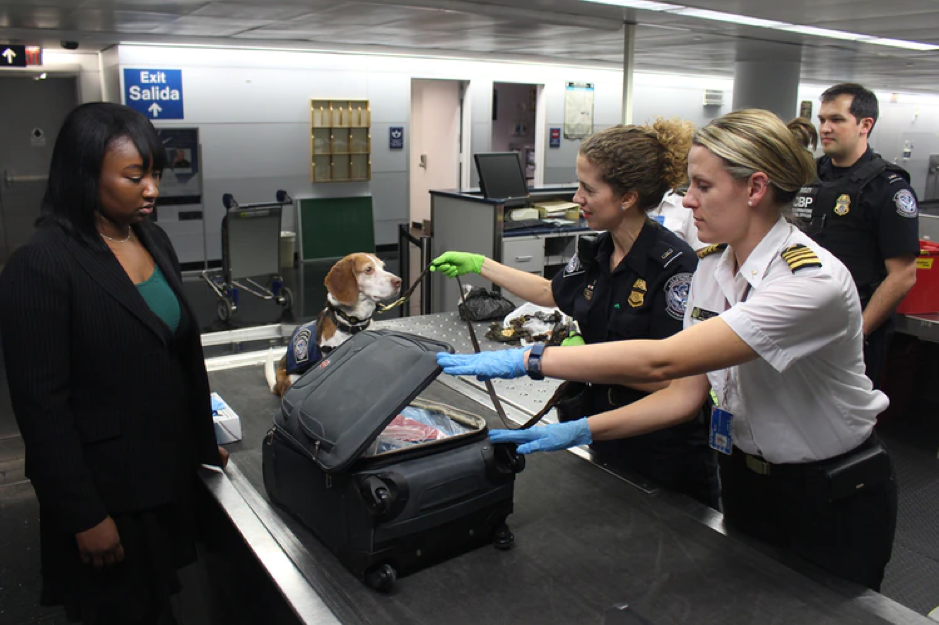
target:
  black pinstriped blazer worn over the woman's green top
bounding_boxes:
[0,222,219,533]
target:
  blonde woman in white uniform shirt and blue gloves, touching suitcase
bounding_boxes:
[438,110,896,589]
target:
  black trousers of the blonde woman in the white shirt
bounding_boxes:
[719,434,897,591]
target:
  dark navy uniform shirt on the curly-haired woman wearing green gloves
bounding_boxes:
[551,220,698,343]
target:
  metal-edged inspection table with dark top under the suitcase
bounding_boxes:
[202,313,932,625]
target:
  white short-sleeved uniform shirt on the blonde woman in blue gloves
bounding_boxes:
[685,218,889,464]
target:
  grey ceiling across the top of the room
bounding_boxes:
[0,0,939,93]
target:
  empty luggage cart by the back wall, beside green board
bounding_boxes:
[202,190,293,322]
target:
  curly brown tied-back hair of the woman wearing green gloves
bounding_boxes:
[580,117,694,211]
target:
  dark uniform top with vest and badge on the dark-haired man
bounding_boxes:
[793,148,919,296]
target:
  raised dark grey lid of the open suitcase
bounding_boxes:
[278,330,453,473]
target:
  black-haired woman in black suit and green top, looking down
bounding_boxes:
[0,102,227,623]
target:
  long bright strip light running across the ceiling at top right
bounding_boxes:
[583,0,939,52]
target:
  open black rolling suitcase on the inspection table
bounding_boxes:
[263,330,524,589]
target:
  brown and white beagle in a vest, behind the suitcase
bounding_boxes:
[265,252,401,396]
